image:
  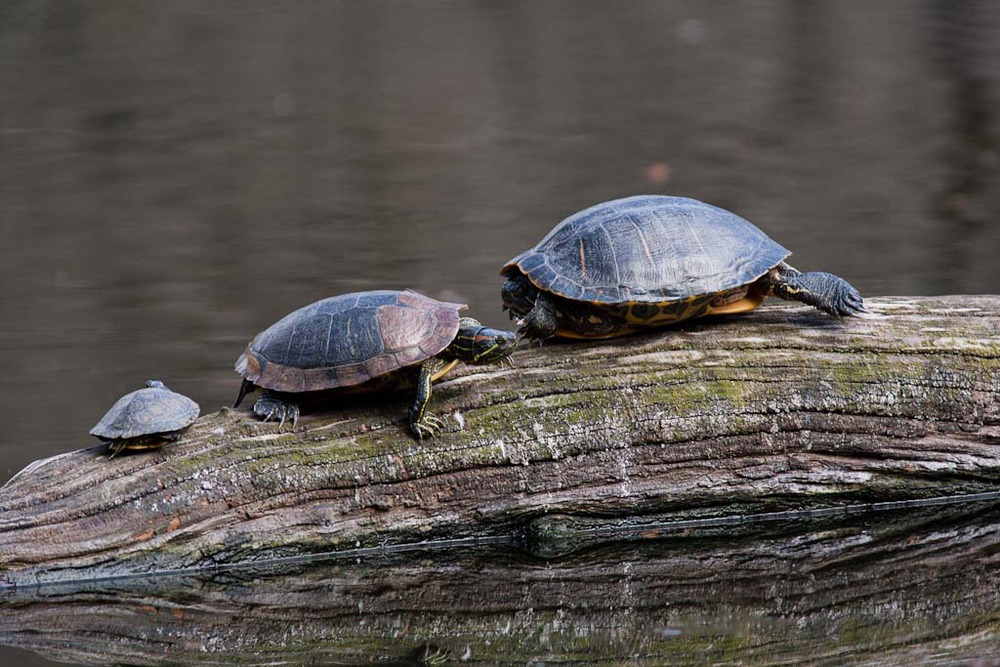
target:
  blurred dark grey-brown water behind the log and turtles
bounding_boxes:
[0,0,1000,664]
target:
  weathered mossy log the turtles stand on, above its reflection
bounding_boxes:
[0,296,1000,586]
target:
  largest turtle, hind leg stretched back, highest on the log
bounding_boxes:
[501,195,864,339]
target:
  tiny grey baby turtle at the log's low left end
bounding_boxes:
[90,380,200,456]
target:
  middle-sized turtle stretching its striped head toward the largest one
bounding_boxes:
[233,290,516,439]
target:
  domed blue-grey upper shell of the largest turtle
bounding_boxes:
[503,195,791,303]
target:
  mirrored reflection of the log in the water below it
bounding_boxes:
[0,500,1000,665]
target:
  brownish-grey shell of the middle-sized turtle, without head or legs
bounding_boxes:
[236,290,465,392]
